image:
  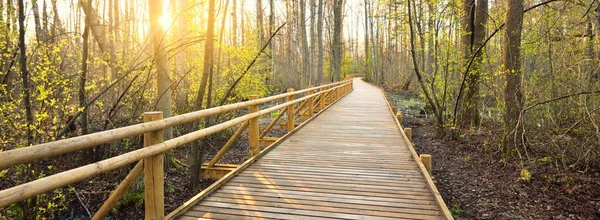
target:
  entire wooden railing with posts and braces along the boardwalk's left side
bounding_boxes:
[0,80,352,219]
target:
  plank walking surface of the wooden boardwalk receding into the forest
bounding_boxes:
[169,79,448,219]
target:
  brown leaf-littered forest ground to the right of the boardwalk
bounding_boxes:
[388,87,600,219]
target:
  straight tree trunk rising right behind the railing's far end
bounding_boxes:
[333,0,344,82]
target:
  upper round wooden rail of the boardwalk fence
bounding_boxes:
[0,81,349,170]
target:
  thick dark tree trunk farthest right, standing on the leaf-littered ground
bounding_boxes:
[502,0,525,156]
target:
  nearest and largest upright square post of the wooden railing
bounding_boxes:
[143,112,165,219]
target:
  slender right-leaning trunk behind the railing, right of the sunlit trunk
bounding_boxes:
[190,0,215,189]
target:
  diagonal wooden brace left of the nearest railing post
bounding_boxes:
[92,161,144,220]
